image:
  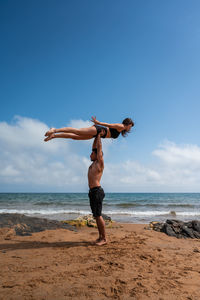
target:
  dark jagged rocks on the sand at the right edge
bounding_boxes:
[148,219,200,239]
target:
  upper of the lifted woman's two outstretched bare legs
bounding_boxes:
[45,126,97,136]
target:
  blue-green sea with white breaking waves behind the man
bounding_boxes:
[0,193,200,224]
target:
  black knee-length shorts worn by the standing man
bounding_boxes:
[88,186,105,217]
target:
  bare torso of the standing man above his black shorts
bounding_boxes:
[88,160,103,189]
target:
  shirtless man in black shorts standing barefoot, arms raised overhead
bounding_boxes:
[88,134,107,246]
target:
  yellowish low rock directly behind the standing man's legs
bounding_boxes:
[62,214,115,227]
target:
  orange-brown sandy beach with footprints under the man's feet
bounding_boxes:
[0,224,200,300]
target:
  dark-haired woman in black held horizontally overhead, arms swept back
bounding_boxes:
[44,117,134,142]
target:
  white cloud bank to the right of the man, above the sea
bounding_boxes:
[101,141,200,192]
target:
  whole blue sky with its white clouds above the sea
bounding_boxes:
[0,0,200,192]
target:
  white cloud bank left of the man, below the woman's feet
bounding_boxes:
[0,117,89,190]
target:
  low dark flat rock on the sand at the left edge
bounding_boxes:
[0,214,75,237]
